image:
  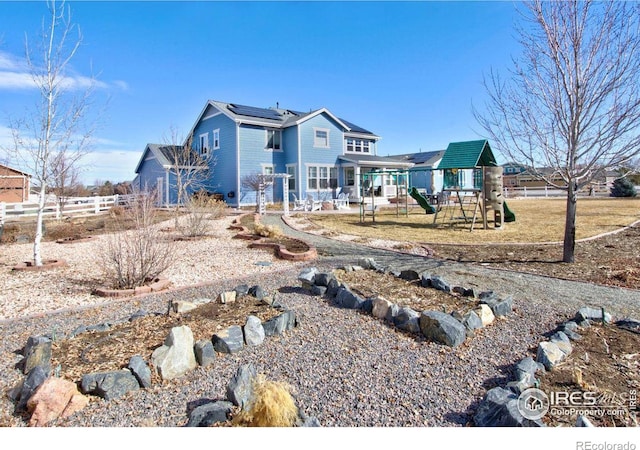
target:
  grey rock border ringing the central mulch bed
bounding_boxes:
[298,258,513,347]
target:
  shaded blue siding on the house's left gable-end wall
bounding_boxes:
[193,110,239,206]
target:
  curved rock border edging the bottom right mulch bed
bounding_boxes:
[473,306,640,427]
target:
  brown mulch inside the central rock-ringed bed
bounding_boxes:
[334,270,477,313]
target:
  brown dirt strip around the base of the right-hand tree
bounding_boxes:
[425,225,640,289]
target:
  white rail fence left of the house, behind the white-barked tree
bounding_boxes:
[0,195,128,224]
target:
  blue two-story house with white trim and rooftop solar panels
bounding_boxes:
[134,100,413,207]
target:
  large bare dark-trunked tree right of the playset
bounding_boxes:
[474,0,640,262]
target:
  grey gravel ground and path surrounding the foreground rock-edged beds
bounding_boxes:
[0,216,640,427]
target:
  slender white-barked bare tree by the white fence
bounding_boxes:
[10,0,94,266]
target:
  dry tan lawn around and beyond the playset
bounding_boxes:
[308,198,640,244]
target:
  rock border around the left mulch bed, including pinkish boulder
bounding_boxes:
[9,285,299,426]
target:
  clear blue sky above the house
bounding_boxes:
[0,1,518,184]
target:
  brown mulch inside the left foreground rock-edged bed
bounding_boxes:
[51,295,281,384]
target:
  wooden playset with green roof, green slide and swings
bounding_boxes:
[360,140,516,231]
